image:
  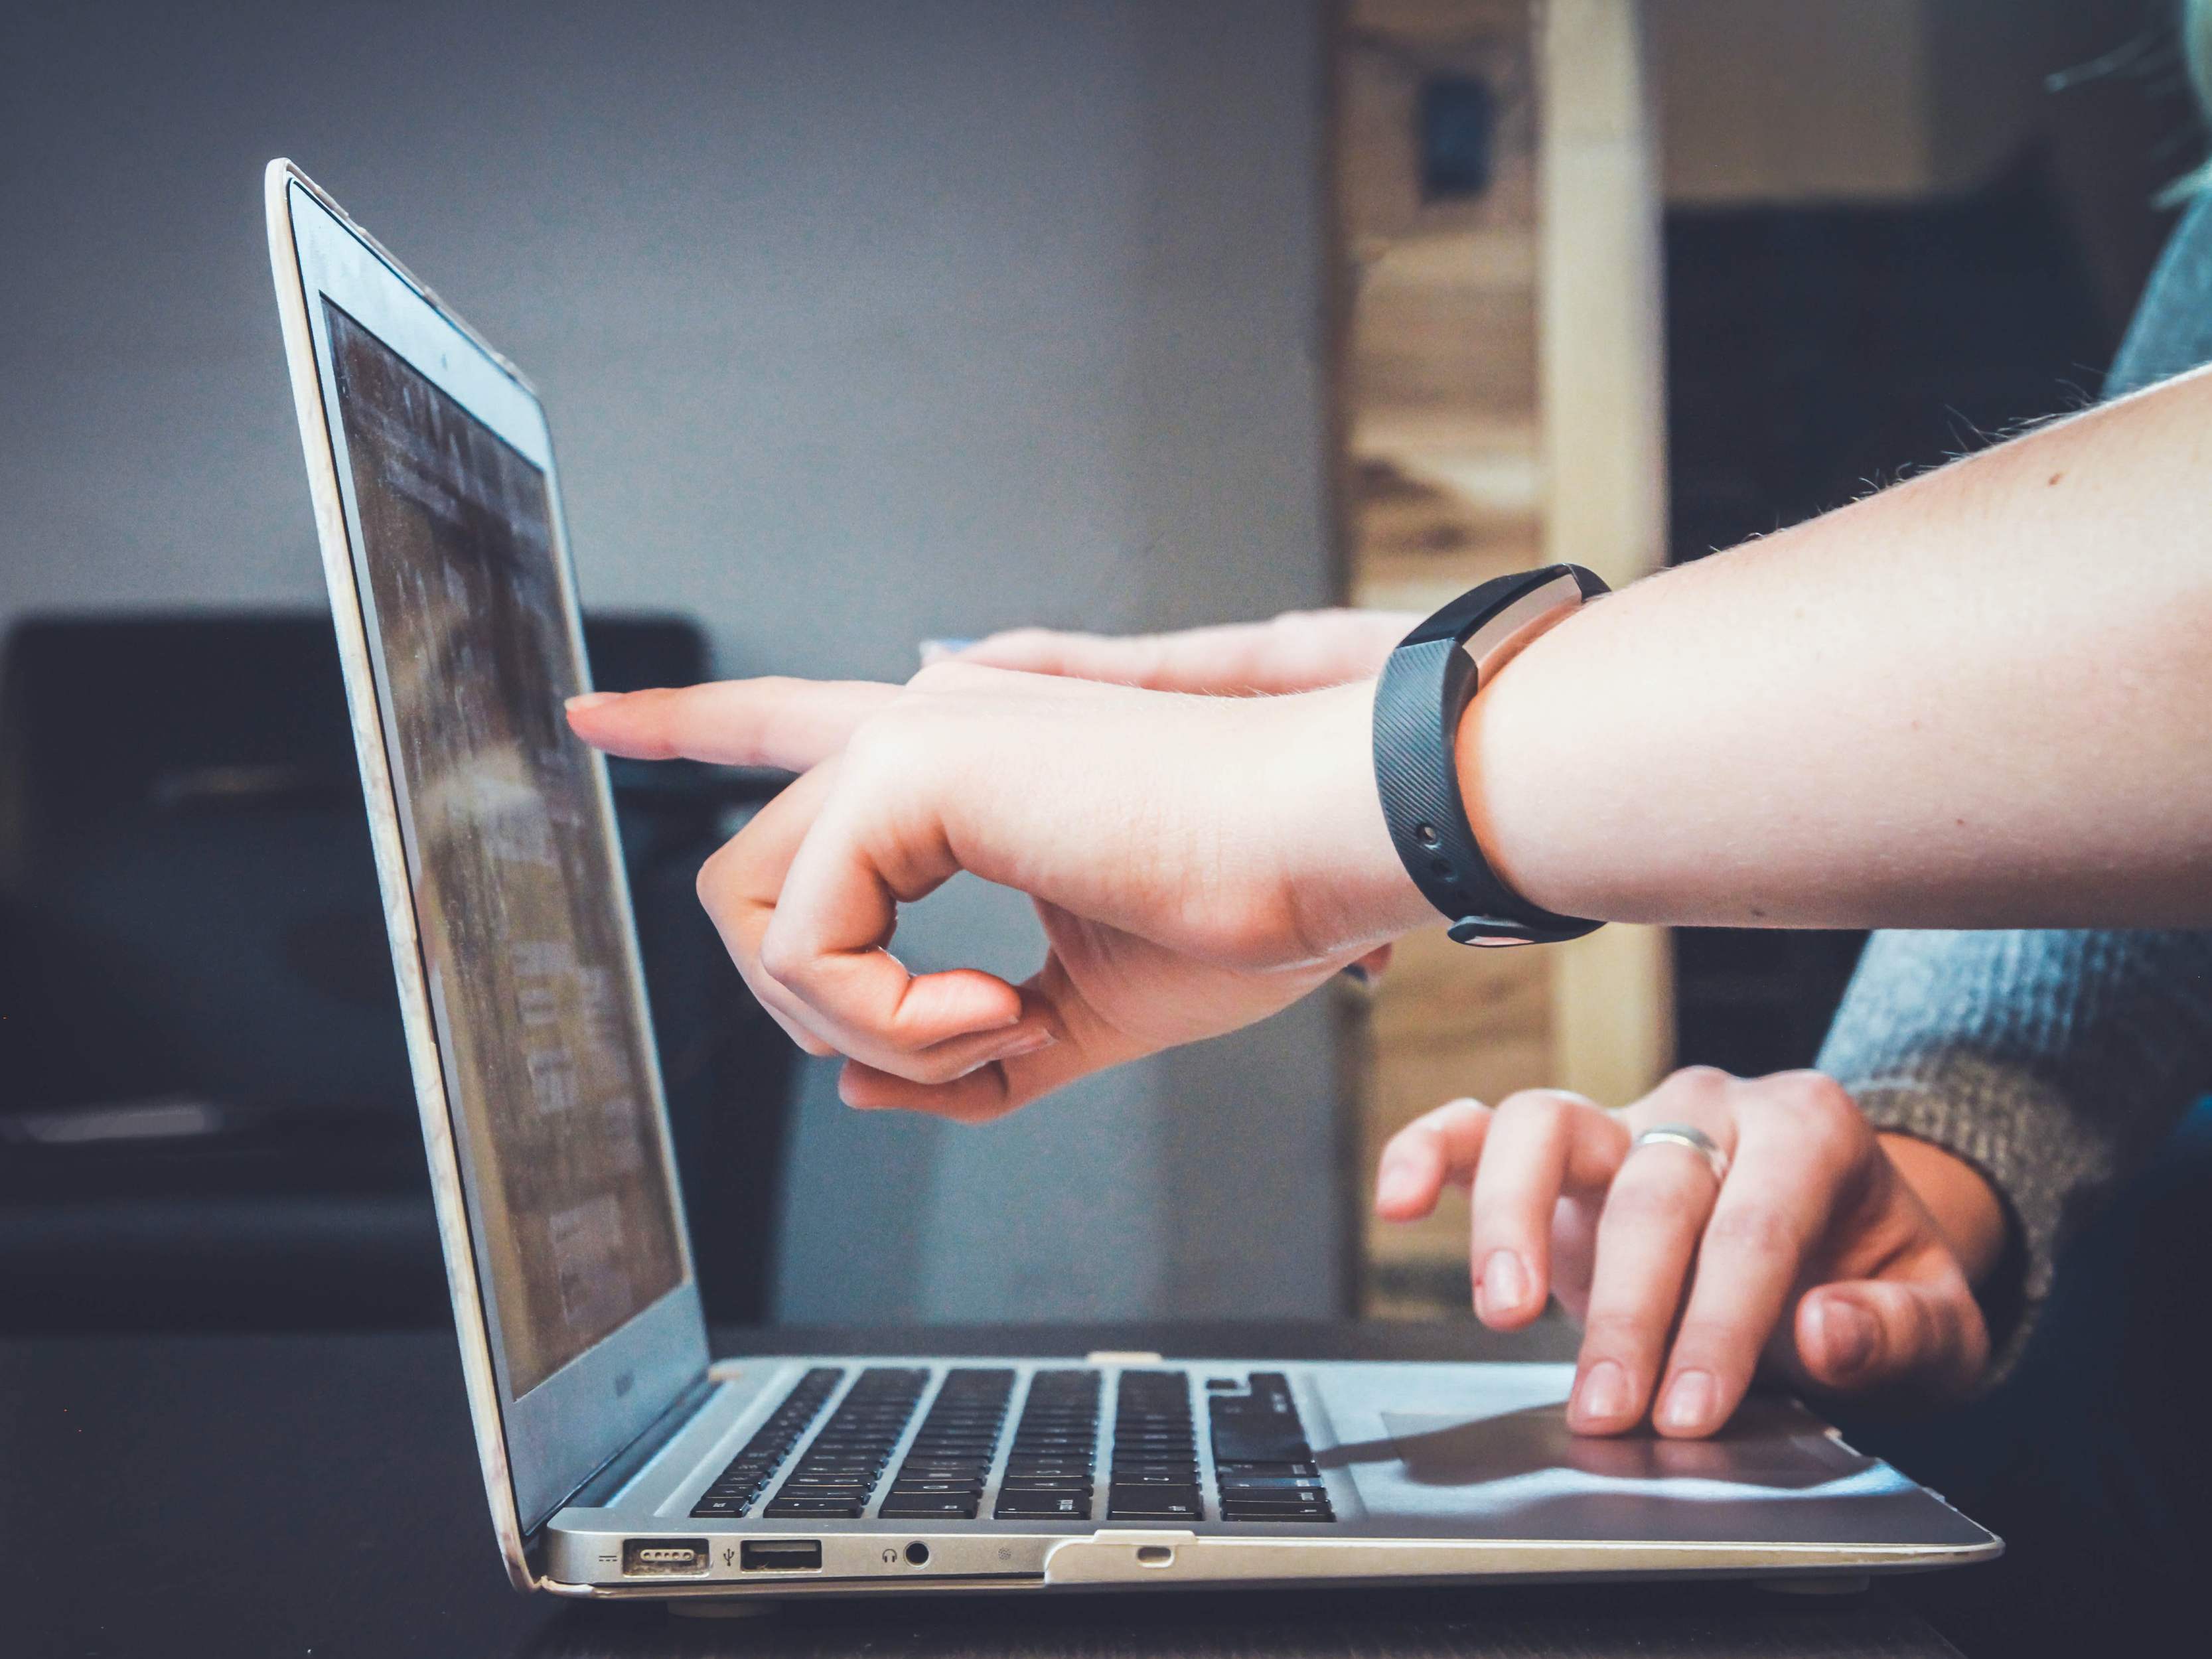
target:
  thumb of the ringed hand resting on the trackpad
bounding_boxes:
[1794,1274,1988,1400]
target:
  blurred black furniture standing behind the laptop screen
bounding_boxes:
[0,613,792,1329]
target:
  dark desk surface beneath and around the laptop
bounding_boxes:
[0,1325,1953,1659]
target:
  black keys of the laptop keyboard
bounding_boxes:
[692,1365,1336,1524]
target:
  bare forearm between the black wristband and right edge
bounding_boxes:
[1460,374,2212,927]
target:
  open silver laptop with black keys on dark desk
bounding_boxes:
[267,161,2002,1599]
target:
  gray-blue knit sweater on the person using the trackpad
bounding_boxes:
[1818,197,2212,1374]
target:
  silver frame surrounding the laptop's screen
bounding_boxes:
[267,161,708,1584]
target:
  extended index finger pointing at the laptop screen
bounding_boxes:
[569,677,898,772]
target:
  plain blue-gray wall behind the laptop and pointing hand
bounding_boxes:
[0,0,1341,1319]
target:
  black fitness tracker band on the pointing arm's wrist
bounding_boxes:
[1376,564,1606,944]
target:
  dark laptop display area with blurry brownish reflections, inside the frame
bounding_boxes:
[325,303,684,1396]
